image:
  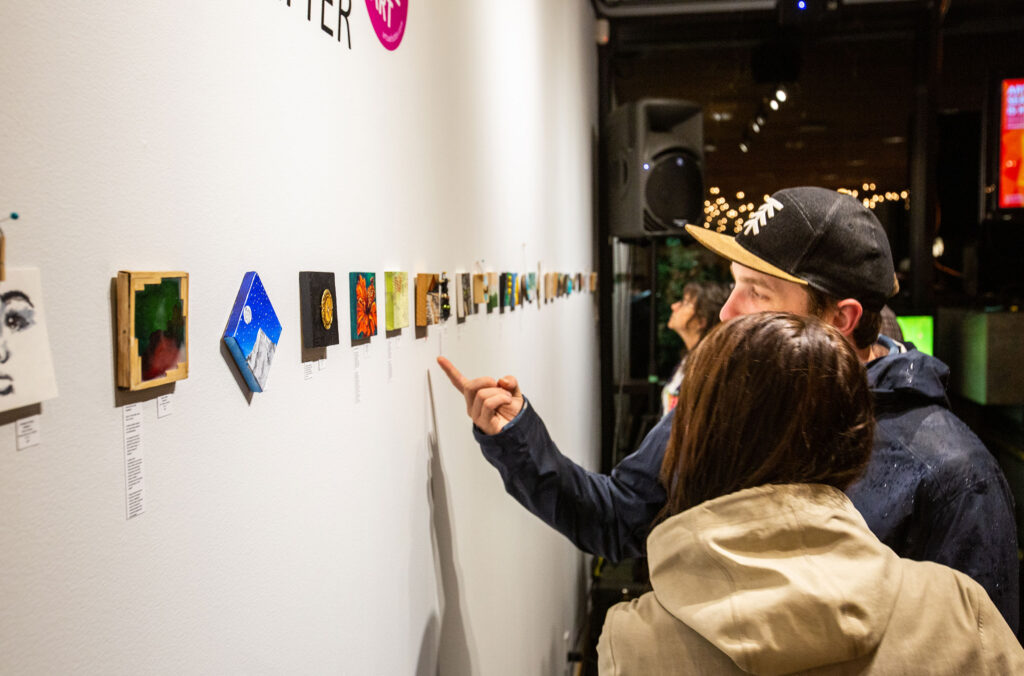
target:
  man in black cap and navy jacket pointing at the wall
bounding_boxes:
[438,187,1021,631]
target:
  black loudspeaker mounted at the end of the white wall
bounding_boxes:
[605,98,705,239]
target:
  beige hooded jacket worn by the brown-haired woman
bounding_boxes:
[597,484,1024,676]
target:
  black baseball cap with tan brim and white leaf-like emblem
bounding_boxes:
[686,187,899,311]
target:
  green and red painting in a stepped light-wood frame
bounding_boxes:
[117,270,188,390]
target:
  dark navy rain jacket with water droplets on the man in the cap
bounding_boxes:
[474,336,1020,633]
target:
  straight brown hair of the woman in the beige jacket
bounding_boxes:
[658,312,874,519]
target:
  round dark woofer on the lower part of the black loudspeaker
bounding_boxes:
[643,149,703,233]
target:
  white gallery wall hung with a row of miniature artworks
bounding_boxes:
[0,0,599,676]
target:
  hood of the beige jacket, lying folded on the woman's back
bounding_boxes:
[647,484,902,674]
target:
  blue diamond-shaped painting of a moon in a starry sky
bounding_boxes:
[224,272,281,392]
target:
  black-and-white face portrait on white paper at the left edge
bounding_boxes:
[0,267,57,411]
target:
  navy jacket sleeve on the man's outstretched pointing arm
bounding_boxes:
[473,405,672,561]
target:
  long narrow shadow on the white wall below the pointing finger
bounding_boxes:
[416,371,472,676]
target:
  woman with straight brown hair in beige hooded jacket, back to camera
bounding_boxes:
[597,312,1024,676]
